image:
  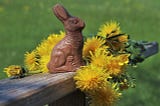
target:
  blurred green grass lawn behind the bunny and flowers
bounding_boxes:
[0,0,160,106]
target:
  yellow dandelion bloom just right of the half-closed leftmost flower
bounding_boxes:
[24,50,40,71]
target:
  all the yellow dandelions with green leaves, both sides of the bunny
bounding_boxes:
[4,21,155,106]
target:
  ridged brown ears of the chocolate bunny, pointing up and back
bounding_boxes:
[53,4,71,22]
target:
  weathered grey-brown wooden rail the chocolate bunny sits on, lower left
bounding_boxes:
[0,72,75,106]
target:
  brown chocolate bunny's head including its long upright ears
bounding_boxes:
[53,4,85,32]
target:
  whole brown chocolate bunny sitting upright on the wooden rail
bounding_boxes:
[47,4,85,73]
